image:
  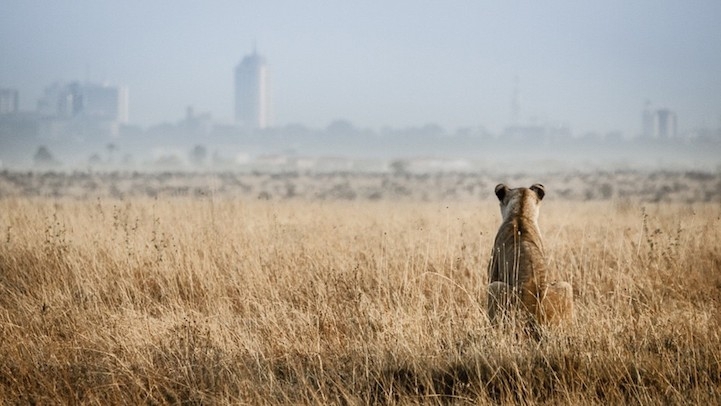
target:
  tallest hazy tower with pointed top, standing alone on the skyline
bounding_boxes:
[235,50,272,129]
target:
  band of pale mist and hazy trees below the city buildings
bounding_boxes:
[0,122,721,173]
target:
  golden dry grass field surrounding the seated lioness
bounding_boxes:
[0,173,721,405]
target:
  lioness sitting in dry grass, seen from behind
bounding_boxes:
[488,183,573,325]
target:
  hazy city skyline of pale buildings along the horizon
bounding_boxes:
[0,60,700,140]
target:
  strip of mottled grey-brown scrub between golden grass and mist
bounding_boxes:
[0,167,721,203]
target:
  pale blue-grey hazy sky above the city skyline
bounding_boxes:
[0,0,721,135]
